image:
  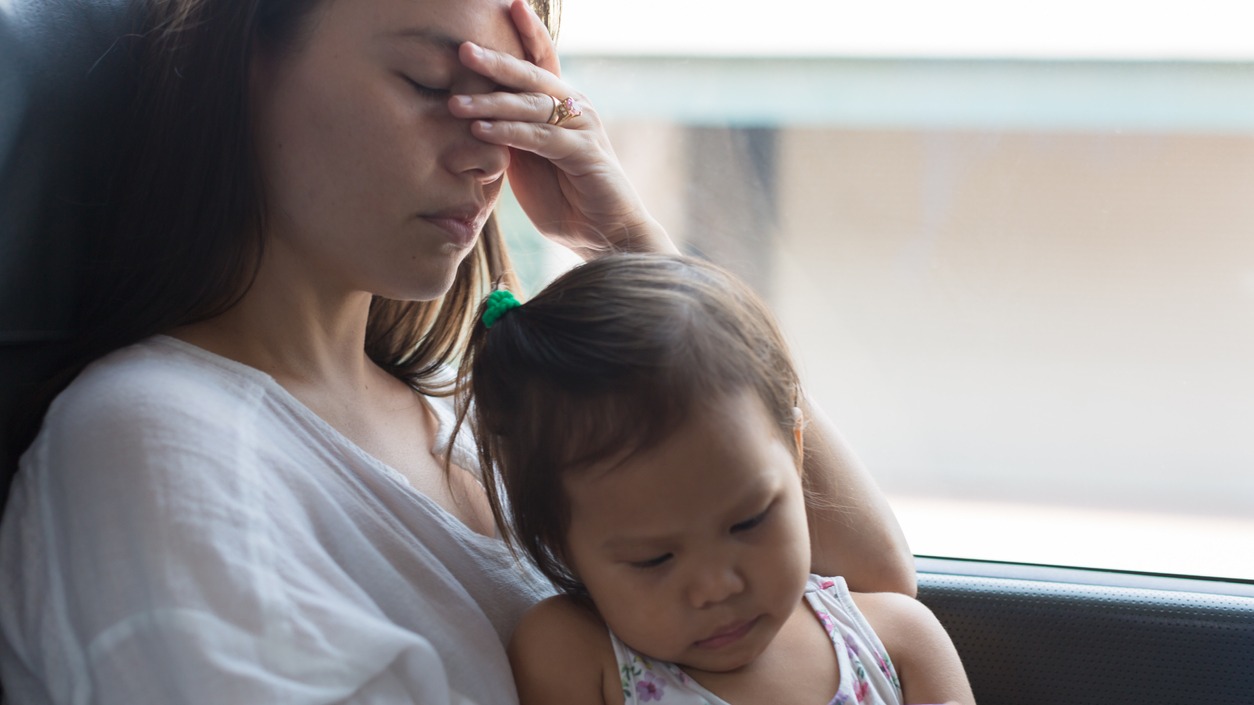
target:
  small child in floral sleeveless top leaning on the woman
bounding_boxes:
[461,255,974,705]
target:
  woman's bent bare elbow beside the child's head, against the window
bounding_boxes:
[803,401,918,597]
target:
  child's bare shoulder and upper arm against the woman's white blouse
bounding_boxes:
[509,596,623,705]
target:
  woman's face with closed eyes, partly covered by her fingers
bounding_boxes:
[252,0,523,300]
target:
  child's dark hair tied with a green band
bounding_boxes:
[458,255,800,595]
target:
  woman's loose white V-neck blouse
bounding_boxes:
[0,336,552,705]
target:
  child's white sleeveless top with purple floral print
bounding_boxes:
[609,576,902,705]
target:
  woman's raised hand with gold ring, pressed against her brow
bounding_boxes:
[449,0,676,258]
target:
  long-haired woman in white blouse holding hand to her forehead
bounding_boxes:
[0,0,913,704]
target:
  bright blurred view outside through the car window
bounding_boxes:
[505,0,1254,580]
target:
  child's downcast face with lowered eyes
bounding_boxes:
[566,393,810,671]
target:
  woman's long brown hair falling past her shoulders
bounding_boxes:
[6,0,558,467]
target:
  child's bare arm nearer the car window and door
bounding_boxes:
[853,592,976,705]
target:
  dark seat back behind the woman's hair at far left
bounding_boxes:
[0,0,130,487]
